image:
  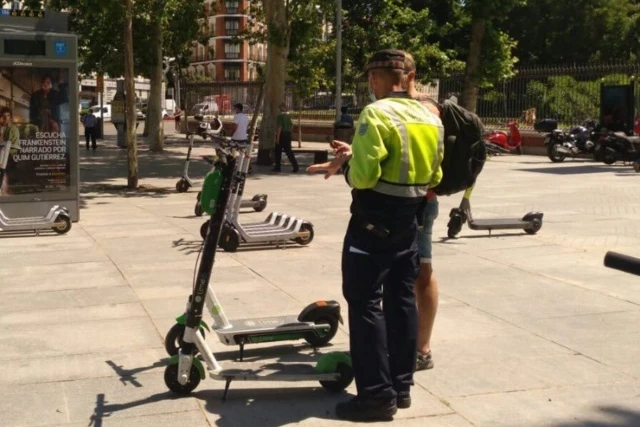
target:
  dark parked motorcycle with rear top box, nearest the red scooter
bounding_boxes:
[533,119,596,163]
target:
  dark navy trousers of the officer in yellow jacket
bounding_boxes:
[342,219,420,399]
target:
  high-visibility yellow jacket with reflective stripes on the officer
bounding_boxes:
[345,97,444,198]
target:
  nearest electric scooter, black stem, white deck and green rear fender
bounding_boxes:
[164,145,353,401]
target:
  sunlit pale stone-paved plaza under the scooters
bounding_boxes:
[0,137,640,427]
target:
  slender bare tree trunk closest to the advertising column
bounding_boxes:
[124,0,138,188]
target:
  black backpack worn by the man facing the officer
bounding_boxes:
[432,100,487,196]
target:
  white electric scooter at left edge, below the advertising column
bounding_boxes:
[0,141,71,235]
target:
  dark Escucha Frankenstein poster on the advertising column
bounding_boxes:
[0,67,70,196]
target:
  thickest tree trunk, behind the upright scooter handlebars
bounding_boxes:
[257,0,290,166]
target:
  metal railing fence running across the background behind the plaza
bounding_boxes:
[186,63,640,129]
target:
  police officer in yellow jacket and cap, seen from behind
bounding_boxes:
[309,50,444,421]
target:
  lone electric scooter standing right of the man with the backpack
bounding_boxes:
[447,187,544,239]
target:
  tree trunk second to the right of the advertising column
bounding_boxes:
[146,8,164,151]
